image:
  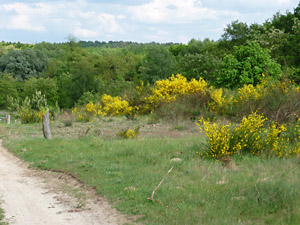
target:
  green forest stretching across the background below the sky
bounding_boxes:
[0,4,300,108]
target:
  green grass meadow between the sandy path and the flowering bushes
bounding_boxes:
[0,118,300,225]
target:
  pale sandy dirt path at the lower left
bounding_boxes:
[0,140,126,225]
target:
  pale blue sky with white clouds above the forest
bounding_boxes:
[0,0,299,43]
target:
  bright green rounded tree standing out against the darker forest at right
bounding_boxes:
[215,42,282,88]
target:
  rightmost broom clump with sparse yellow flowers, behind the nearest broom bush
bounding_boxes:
[230,77,300,122]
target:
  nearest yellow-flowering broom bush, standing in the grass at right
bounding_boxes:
[197,112,300,159]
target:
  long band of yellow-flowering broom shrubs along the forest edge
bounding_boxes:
[69,74,300,123]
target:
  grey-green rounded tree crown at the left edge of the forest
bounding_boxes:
[0,48,48,81]
